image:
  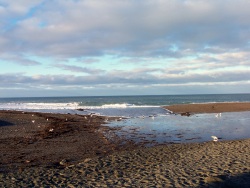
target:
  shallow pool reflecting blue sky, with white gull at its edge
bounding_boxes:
[109,112,250,144]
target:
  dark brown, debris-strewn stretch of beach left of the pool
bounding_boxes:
[0,110,139,172]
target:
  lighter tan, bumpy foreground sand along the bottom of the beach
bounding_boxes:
[0,139,250,187]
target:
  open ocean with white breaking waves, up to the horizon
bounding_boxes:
[0,94,250,117]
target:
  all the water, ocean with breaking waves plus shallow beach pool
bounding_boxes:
[0,94,250,143]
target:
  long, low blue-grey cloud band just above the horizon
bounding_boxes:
[0,70,250,88]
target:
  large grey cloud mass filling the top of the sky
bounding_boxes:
[0,0,250,57]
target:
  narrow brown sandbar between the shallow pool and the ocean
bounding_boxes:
[164,102,250,114]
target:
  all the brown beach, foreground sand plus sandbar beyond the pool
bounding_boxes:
[0,103,250,187]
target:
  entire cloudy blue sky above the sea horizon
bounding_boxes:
[0,0,250,97]
